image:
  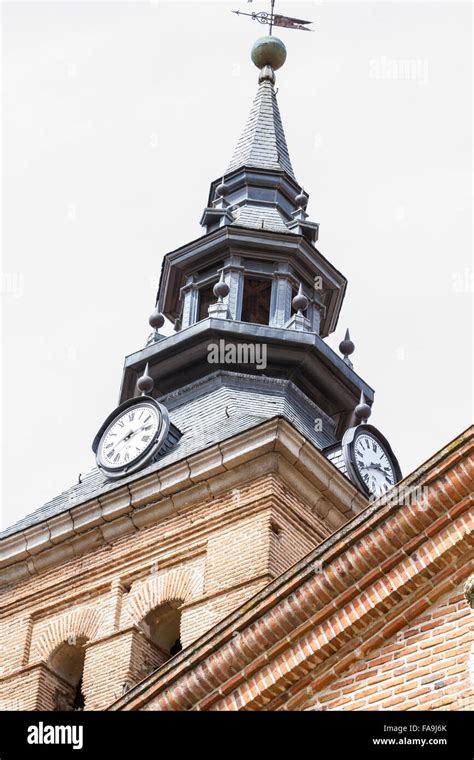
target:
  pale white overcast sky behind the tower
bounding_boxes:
[1,0,472,527]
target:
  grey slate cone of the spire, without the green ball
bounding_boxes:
[226,79,296,180]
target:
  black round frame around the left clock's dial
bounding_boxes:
[92,395,170,480]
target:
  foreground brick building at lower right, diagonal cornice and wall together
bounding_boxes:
[104,429,474,711]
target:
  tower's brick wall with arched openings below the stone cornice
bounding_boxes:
[0,467,330,709]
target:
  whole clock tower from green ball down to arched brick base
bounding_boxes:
[0,16,406,710]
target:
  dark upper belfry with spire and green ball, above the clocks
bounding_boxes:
[120,36,373,449]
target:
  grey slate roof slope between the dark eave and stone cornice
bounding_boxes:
[0,372,335,539]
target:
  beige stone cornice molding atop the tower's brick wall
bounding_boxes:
[0,417,367,587]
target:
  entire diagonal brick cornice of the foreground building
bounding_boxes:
[110,428,474,710]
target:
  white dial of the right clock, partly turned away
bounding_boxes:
[354,431,396,496]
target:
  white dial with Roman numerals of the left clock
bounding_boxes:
[98,404,160,469]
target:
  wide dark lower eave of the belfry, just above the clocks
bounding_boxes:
[119,318,374,436]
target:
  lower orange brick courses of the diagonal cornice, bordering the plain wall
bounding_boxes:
[209,520,469,710]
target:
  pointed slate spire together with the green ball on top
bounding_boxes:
[226,37,296,180]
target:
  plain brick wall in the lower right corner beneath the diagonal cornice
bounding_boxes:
[302,588,474,710]
